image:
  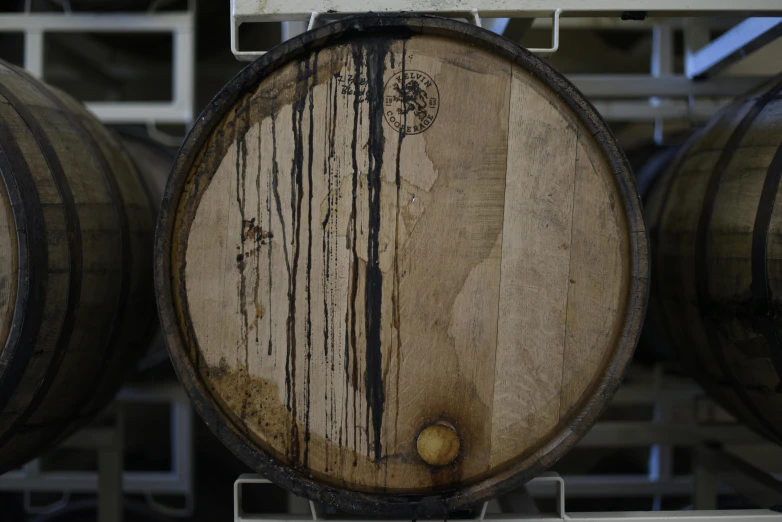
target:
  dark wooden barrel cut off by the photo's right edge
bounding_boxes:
[646,77,782,442]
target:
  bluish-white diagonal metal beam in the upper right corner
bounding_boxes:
[685,17,782,78]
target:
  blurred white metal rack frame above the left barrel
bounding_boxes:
[0,0,195,126]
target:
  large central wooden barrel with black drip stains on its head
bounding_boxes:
[155,16,647,516]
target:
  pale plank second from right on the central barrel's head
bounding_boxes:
[491,74,578,465]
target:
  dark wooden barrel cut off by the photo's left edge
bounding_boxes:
[0,59,154,473]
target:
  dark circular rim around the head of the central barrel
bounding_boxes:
[155,16,647,516]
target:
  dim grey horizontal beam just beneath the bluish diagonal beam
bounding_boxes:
[568,74,768,99]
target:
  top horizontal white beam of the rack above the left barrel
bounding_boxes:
[0,11,195,33]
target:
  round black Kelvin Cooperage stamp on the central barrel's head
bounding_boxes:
[383,71,440,134]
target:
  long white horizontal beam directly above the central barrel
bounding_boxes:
[236,0,782,22]
